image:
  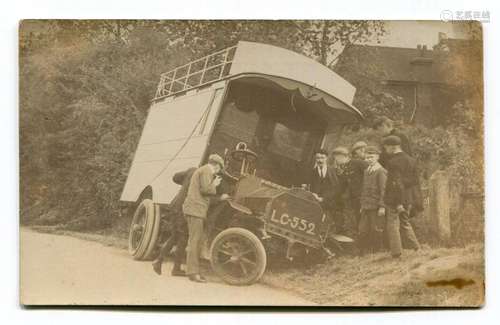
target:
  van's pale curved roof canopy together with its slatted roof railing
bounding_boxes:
[154,41,362,118]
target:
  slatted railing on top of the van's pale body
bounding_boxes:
[154,46,236,100]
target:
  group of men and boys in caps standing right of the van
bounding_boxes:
[309,117,422,258]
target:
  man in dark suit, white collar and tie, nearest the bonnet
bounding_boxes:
[309,149,343,232]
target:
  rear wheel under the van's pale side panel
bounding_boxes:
[128,199,160,260]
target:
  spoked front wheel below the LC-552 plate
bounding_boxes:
[210,228,267,285]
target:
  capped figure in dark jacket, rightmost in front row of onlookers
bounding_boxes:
[383,135,420,257]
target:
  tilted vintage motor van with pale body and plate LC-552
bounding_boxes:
[121,42,362,285]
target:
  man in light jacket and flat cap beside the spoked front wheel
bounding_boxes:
[182,154,224,282]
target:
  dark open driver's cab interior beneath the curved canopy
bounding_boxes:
[208,77,327,187]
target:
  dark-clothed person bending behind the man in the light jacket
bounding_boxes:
[153,167,196,276]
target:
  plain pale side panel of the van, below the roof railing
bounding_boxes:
[120,88,224,203]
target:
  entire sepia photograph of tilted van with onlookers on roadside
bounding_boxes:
[18,18,484,310]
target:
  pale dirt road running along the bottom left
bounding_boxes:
[20,229,314,305]
